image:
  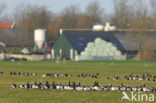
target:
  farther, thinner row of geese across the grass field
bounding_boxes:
[0,72,156,82]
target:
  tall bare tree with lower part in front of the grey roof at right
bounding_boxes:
[129,0,152,55]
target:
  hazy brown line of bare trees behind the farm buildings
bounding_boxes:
[0,0,156,46]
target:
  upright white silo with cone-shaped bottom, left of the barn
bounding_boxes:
[34,29,46,49]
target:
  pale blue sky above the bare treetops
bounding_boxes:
[0,0,113,14]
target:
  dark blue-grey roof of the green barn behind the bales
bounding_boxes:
[63,30,125,51]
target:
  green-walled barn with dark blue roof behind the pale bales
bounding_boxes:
[52,30,125,59]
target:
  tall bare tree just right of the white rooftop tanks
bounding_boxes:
[111,0,133,29]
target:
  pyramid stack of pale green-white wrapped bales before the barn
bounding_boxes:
[75,38,126,60]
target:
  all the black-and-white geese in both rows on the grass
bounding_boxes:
[0,72,156,92]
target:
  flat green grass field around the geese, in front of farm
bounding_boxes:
[0,61,156,103]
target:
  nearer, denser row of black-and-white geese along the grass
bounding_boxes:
[11,81,156,92]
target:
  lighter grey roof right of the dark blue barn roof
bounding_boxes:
[114,32,156,51]
